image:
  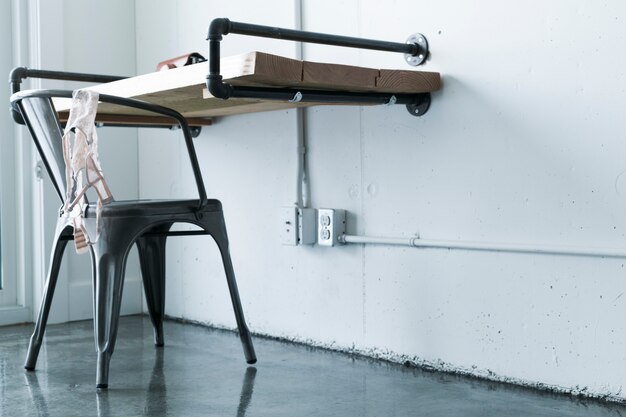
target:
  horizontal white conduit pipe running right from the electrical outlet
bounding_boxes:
[338,234,626,258]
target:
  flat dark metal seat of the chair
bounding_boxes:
[85,199,222,218]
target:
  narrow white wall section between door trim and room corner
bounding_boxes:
[58,0,142,320]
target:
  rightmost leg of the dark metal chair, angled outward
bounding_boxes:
[207,213,256,364]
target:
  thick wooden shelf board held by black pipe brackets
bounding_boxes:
[55,52,441,124]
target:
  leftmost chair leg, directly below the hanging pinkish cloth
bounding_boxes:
[24,223,67,371]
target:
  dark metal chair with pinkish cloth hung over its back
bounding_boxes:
[11,90,256,388]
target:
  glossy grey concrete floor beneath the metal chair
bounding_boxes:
[0,316,626,417]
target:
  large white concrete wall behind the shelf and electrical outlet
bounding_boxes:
[136,0,626,397]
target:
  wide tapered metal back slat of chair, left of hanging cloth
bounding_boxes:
[18,97,67,201]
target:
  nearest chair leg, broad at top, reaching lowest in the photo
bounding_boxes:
[93,244,126,389]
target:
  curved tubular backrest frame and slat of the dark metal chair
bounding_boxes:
[11,90,208,208]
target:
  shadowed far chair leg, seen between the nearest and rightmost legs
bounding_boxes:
[137,232,167,346]
